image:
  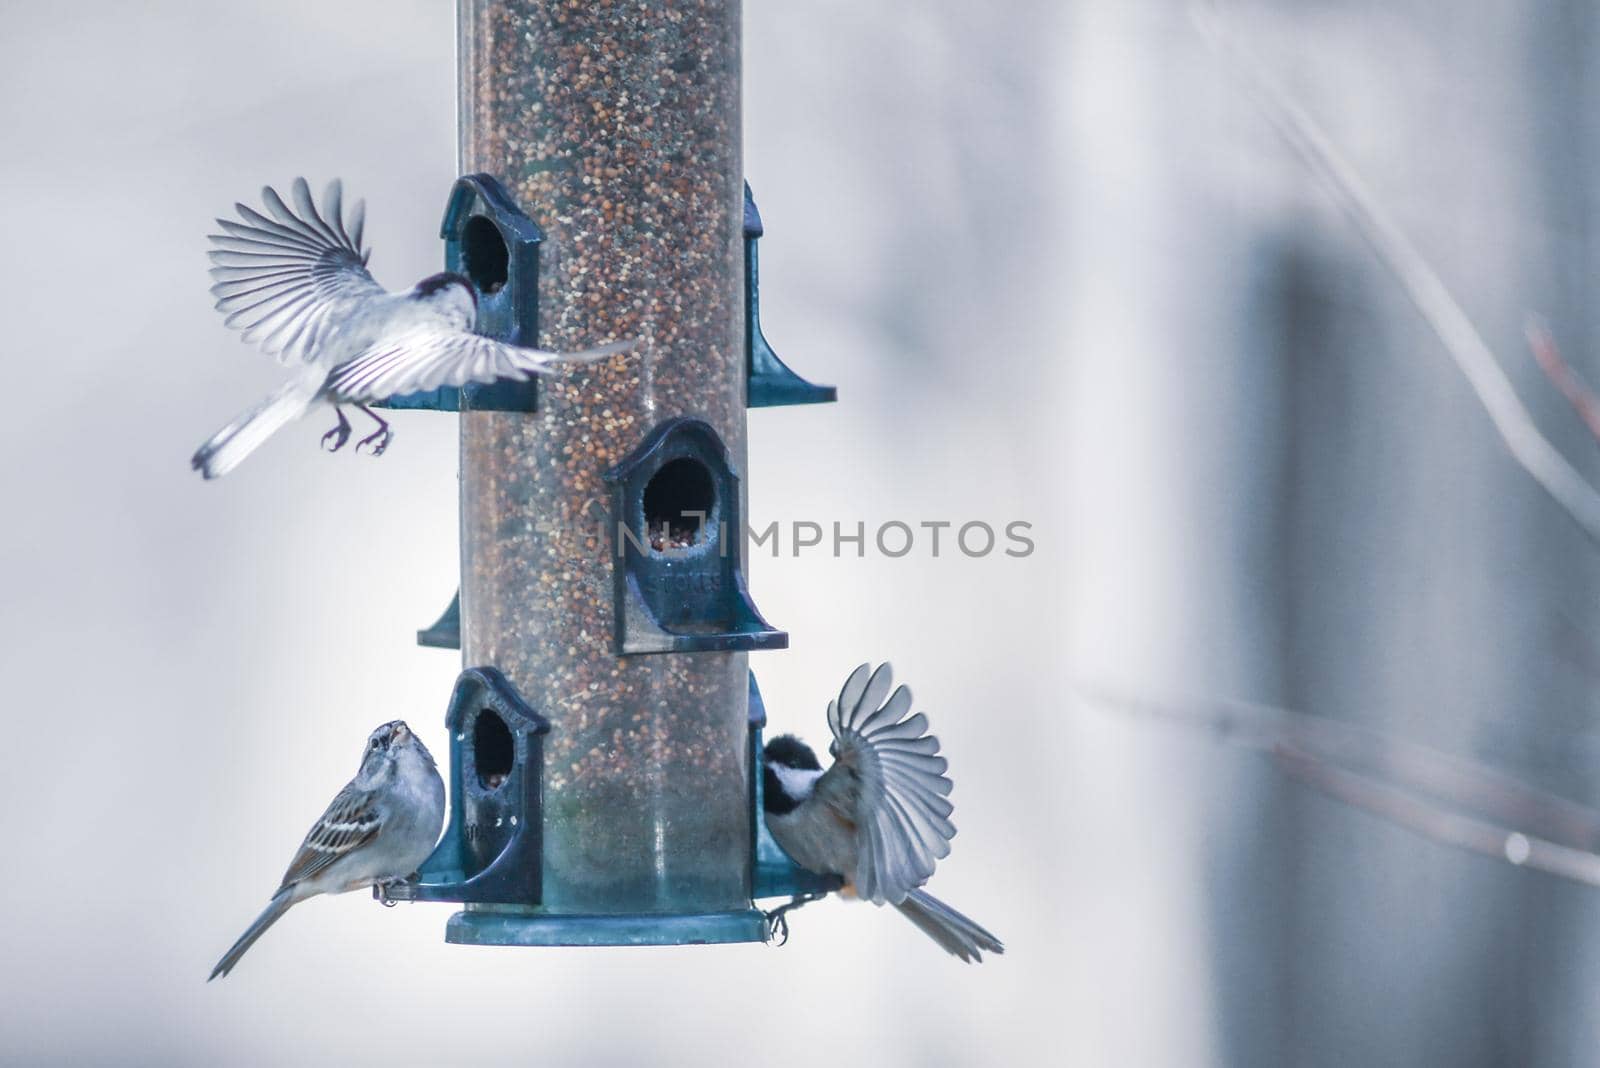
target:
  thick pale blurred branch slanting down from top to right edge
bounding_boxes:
[1190,0,1600,542]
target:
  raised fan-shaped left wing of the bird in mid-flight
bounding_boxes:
[211,177,384,363]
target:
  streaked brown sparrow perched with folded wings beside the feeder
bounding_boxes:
[208,719,445,982]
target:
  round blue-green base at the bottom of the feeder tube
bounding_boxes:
[445,905,766,945]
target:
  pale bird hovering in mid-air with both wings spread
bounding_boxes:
[190,177,634,478]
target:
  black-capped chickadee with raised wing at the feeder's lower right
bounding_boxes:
[762,664,1005,961]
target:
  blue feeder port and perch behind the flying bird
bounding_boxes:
[379,174,544,412]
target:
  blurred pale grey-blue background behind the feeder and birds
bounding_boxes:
[0,0,1600,1065]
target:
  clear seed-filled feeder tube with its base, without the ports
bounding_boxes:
[450,0,762,943]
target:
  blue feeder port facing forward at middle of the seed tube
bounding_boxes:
[605,419,789,656]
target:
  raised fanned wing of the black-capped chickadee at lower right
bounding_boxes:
[816,664,955,903]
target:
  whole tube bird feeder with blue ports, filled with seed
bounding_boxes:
[380,0,835,945]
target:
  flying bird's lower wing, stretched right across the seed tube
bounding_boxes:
[325,326,635,404]
